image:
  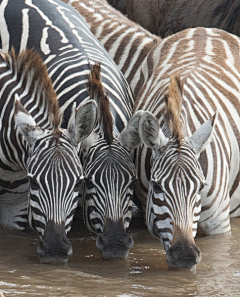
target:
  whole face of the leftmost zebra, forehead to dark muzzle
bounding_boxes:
[28,135,83,262]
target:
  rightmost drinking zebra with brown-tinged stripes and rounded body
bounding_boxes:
[134,28,240,268]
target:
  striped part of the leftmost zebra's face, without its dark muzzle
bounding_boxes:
[27,135,83,238]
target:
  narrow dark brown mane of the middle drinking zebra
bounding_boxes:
[89,63,113,145]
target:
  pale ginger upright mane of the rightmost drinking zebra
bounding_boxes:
[164,75,183,147]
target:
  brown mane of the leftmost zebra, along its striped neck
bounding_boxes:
[0,48,62,129]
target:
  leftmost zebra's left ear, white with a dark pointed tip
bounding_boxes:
[14,94,44,145]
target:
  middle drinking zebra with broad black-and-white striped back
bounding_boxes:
[0,0,141,258]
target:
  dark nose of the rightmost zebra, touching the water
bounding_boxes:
[167,241,202,269]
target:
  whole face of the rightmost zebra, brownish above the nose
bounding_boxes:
[147,142,205,260]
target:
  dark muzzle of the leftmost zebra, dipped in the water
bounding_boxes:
[37,221,73,264]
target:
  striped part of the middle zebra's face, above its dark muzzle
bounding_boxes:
[83,139,136,233]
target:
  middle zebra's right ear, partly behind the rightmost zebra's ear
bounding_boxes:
[119,110,144,152]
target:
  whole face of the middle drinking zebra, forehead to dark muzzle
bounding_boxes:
[83,139,136,259]
